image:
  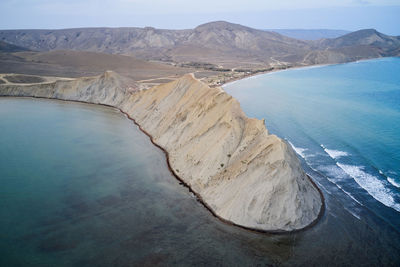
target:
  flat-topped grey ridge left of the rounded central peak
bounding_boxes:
[0,27,189,54]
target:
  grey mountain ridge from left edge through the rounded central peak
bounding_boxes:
[0,21,309,65]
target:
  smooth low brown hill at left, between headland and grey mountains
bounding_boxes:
[0,50,209,87]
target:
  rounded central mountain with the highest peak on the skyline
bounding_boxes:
[161,21,309,67]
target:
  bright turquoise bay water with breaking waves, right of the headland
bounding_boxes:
[225,58,400,229]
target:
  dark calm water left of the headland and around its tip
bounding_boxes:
[0,98,400,266]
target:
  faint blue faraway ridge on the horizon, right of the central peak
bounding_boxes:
[266,29,350,40]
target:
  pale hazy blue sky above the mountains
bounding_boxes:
[0,0,400,35]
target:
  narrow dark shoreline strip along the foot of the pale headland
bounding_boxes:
[0,96,326,235]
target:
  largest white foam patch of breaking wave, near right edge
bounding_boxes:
[336,163,400,212]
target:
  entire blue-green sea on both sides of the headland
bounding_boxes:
[0,58,400,266]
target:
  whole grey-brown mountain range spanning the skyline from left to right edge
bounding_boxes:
[0,21,400,70]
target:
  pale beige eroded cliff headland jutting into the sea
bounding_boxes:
[0,72,323,231]
